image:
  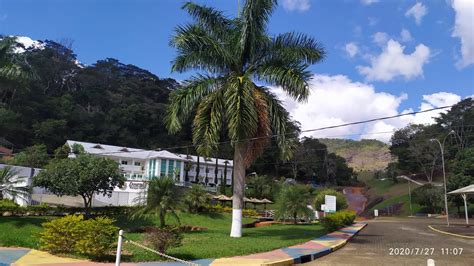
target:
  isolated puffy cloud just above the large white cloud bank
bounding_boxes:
[357,40,430,81]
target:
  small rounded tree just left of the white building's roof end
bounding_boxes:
[13,144,49,168]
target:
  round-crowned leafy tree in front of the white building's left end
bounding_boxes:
[33,154,125,215]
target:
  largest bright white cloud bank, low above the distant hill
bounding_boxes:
[273,75,461,142]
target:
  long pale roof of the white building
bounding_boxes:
[66,140,232,163]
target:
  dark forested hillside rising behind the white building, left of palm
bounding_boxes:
[0,41,190,152]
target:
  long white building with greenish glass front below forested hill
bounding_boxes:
[66,140,233,206]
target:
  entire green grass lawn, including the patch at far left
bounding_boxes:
[0,213,325,262]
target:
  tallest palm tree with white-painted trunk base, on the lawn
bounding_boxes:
[165,0,324,237]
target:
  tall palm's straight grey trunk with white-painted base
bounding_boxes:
[230,142,245,237]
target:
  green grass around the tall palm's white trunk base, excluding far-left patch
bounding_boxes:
[119,213,325,261]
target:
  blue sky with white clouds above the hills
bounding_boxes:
[0,0,474,141]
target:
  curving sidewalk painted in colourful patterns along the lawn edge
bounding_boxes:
[0,222,367,266]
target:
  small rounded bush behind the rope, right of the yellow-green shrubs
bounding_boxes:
[145,227,183,253]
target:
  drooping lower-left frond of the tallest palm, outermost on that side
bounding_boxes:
[165,75,224,133]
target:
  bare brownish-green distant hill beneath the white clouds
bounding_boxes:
[319,139,392,171]
